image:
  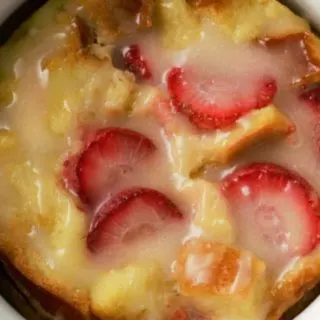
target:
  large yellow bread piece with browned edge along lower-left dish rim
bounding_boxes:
[0,159,89,314]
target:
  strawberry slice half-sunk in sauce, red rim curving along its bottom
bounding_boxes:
[167,68,277,130]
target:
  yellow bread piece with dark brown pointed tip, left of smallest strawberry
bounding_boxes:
[42,15,135,135]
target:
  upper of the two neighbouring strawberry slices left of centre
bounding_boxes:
[76,128,156,204]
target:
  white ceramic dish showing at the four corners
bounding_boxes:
[0,0,320,320]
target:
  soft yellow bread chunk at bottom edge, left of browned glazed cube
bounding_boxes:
[91,261,166,320]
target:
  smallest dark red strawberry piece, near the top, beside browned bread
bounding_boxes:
[122,44,152,80]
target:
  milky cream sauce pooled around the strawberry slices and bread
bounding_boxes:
[0,5,320,320]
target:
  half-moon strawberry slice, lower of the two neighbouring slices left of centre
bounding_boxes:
[87,188,183,252]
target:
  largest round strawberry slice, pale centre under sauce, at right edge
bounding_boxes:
[223,163,320,268]
